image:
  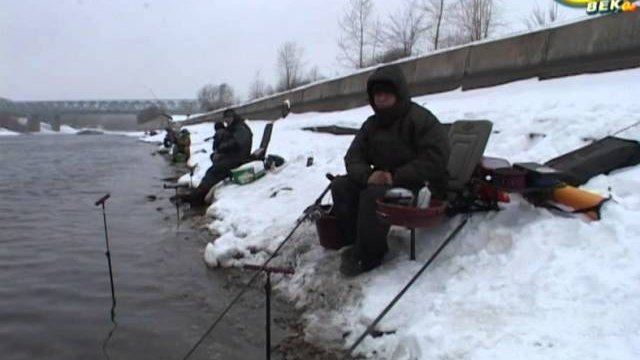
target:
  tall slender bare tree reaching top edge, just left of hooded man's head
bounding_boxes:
[338,0,373,69]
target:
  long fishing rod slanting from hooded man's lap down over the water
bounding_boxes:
[182,174,334,360]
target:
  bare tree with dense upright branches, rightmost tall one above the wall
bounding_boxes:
[454,0,498,42]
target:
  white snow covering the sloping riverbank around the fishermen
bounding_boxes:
[149,69,640,360]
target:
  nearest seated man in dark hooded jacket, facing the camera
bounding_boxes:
[331,65,449,276]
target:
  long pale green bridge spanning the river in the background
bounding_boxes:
[0,99,198,131]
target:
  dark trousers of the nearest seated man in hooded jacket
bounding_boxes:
[331,176,389,266]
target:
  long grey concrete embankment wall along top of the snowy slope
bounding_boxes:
[185,12,640,124]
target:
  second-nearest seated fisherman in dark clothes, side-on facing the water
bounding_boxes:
[188,109,253,206]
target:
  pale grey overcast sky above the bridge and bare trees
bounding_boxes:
[0,0,584,100]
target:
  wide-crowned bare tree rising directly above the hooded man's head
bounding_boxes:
[384,0,429,57]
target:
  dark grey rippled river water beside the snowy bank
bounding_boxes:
[0,135,278,360]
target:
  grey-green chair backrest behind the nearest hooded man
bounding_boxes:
[447,120,493,191]
